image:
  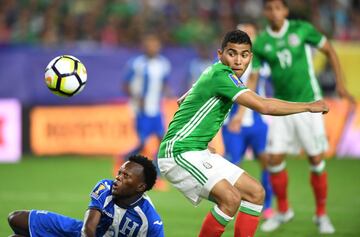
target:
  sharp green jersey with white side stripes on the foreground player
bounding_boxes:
[158,62,248,158]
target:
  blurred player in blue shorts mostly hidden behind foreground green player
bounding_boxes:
[222,23,273,219]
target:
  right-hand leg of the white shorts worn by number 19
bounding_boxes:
[294,113,328,156]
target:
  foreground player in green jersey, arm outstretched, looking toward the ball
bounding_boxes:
[158,30,328,237]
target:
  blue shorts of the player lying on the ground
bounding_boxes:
[29,210,83,237]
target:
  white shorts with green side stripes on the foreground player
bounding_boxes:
[158,150,243,205]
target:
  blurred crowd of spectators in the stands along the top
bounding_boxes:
[0,0,360,46]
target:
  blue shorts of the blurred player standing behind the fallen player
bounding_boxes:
[136,113,164,143]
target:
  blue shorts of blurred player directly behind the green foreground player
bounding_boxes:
[222,122,268,164]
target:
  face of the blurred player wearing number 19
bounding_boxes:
[264,0,289,30]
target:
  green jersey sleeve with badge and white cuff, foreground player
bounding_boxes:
[213,70,248,101]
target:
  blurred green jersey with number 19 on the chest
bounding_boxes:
[252,20,326,102]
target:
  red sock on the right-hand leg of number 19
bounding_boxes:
[310,161,327,216]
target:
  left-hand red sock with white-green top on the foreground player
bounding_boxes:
[199,205,233,237]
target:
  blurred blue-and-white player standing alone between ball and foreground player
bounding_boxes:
[123,33,171,189]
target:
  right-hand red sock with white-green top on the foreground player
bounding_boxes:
[234,201,263,237]
